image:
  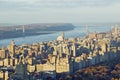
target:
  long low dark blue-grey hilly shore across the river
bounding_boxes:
[0,23,75,39]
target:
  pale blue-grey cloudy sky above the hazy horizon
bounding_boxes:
[0,0,120,24]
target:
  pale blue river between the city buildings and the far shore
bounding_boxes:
[0,26,111,47]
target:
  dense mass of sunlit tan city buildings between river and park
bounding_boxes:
[0,28,120,80]
